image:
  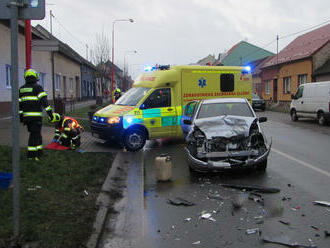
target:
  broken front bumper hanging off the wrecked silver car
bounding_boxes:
[185,144,271,172]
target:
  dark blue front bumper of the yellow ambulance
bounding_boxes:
[91,121,124,142]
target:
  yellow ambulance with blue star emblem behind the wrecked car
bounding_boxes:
[91,66,252,151]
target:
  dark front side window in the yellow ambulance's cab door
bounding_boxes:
[142,88,171,109]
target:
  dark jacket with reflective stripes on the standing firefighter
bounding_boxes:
[19,82,53,123]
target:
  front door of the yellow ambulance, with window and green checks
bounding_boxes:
[140,88,177,139]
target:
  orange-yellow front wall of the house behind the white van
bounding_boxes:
[277,59,312,101]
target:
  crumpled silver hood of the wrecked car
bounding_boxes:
[194,115,257,139]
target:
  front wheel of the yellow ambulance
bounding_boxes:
[124,129,147,152]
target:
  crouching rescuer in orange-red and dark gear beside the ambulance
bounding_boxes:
[53,113,84,150]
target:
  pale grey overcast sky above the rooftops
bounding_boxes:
[33,0,330,77]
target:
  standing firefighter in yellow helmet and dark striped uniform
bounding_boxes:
[19,69,54,161]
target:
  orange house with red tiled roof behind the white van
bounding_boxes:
[261,24,330,105]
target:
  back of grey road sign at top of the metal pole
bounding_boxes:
[0,0,45,20]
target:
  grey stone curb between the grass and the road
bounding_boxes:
[86,153,124,248]
